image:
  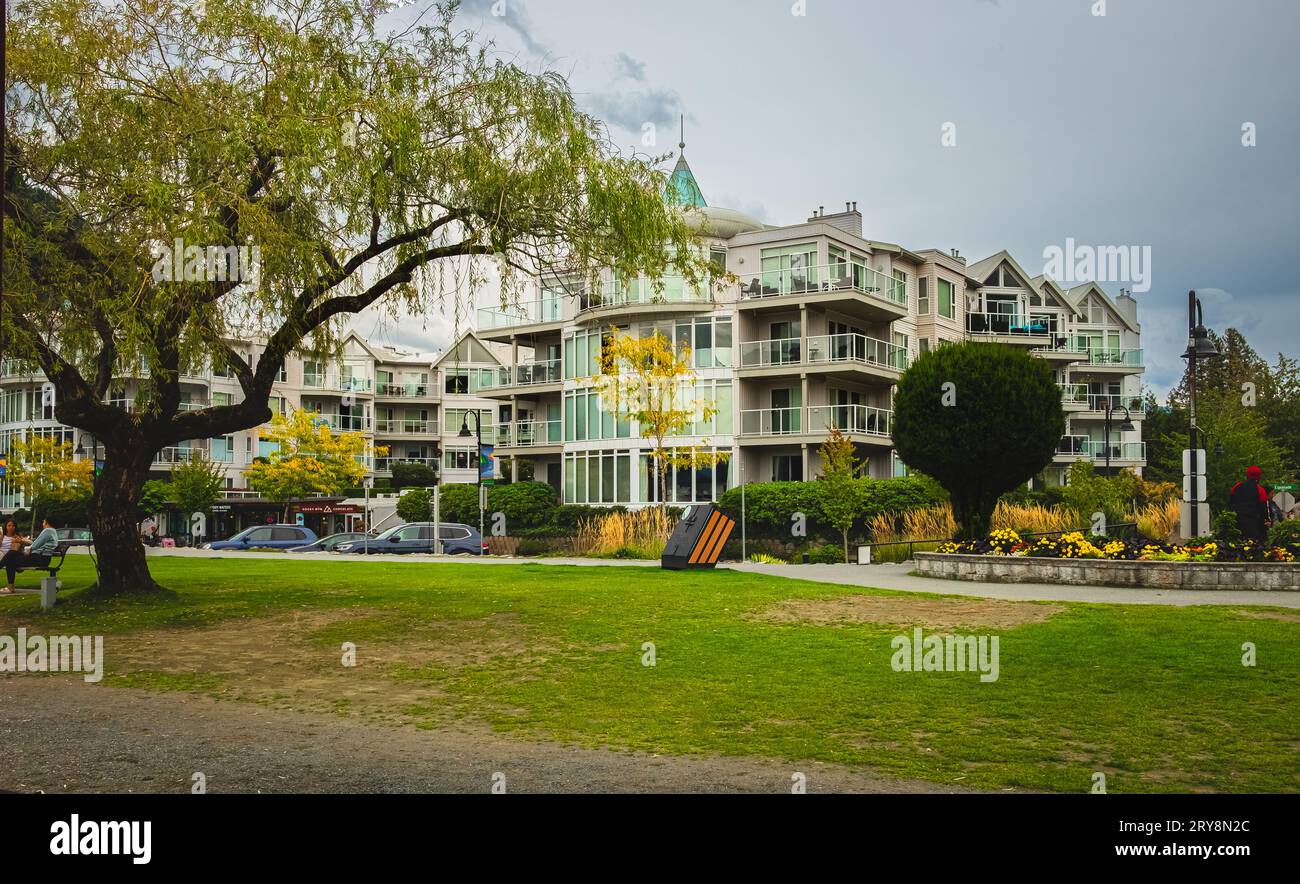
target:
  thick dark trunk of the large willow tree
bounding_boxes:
[90,443,168,597]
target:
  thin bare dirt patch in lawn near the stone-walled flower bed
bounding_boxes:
[758,595,1065,629]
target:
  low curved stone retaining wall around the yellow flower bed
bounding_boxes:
[917,553,1300,592]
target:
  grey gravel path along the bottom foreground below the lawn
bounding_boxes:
[0,675,963,794]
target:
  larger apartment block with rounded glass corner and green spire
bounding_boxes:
[477,150,1145,506]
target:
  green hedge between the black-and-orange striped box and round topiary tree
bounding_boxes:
[719,476,944,543]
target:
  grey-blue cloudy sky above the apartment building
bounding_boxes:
[359,0,1300,391]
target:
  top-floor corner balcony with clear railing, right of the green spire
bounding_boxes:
[740,264,907,321]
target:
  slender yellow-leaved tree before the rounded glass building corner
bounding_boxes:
[593,328,731,502]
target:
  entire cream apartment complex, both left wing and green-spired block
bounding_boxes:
[0,156,1145,516]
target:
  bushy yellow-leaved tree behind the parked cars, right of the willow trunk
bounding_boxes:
[244,411,384,520]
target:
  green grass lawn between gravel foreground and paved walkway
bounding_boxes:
[0,556,1300,792]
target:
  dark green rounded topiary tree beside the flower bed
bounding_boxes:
[893,342,1065,538]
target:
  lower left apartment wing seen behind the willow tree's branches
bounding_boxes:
[0,332,502,533]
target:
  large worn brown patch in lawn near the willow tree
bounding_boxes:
[104,608,549,723]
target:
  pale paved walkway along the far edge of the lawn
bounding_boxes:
[53,549,1300,608]
